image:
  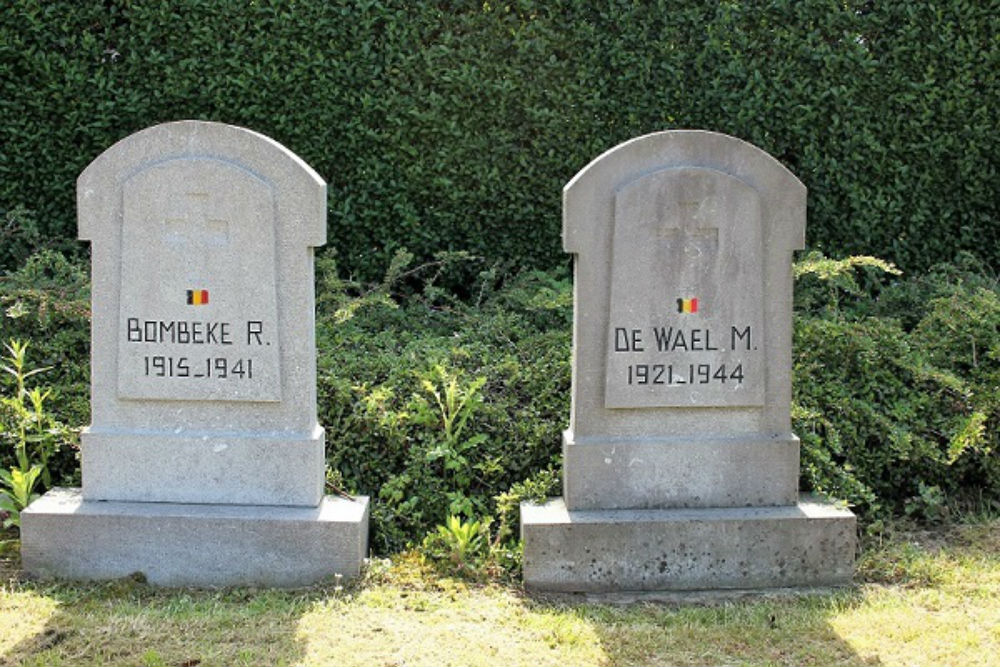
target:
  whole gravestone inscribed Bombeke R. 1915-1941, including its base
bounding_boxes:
[21,121,368,586]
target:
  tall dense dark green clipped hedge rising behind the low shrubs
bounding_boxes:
[0,0,1000,279]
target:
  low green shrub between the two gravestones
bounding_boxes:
[318,254,571,553]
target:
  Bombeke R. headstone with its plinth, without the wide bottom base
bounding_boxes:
[77,121,326,505]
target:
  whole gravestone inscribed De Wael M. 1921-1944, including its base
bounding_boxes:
[521,131,855,592]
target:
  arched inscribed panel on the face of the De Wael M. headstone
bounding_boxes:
[605,168,766,408]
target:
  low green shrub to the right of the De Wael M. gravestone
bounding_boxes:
[793,258,1000,520]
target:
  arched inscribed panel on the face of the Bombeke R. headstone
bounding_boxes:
[118,159,281,401]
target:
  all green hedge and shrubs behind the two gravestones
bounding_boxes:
[0,0,1000,572]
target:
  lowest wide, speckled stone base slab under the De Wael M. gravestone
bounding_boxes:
[521,497,856,593]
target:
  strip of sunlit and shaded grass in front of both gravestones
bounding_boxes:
[0,519,1000,667]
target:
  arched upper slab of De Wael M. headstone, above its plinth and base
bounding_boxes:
[563,130,806,490]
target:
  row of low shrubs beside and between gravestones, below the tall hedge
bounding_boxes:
[0,247,1000,560]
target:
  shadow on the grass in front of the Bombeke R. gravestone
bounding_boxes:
[0,579,330,667]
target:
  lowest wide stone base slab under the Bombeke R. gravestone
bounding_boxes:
[21,488,368,587]
